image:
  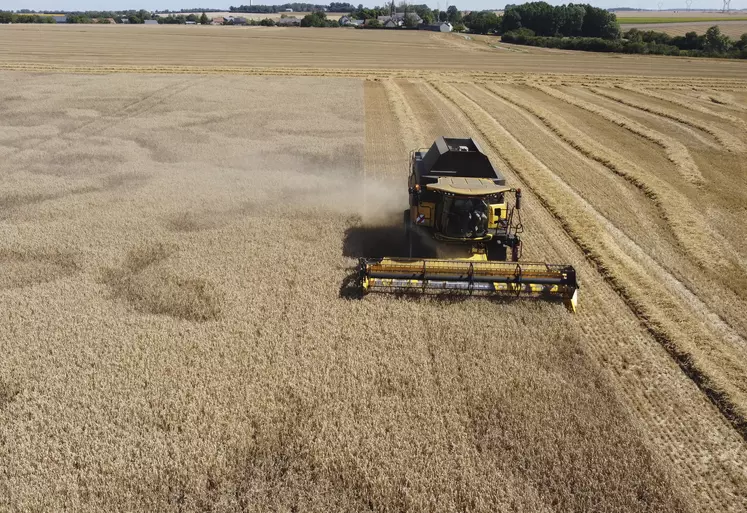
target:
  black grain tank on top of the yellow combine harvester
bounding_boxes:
[414,137,506,185]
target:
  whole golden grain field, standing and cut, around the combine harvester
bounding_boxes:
[0,27,747,512]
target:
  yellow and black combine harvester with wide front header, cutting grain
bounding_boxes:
[358,137,579,312]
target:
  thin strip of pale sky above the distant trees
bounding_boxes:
[0,0,747,11]
